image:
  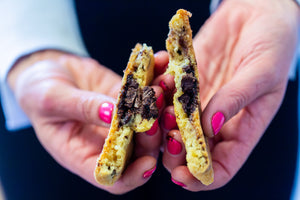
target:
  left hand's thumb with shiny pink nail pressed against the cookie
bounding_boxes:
[40,86,116,127]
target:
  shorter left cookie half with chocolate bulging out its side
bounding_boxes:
[94,44,158,185]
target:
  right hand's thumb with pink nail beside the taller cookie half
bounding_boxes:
[201,68,274,137]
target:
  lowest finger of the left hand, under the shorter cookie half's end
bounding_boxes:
[113,156,156,194]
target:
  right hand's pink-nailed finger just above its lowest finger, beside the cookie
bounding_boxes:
[163,130,186,172]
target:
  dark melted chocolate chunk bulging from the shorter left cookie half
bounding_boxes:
[117,74,158,127]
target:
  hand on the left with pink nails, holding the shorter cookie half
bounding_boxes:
[8,50,162,194]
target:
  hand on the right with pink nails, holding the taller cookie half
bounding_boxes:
[155,0,299,191]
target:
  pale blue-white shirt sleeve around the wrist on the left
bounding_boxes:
[0,0,88,131]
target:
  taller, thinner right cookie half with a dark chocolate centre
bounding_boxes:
[166,9,214,185]
